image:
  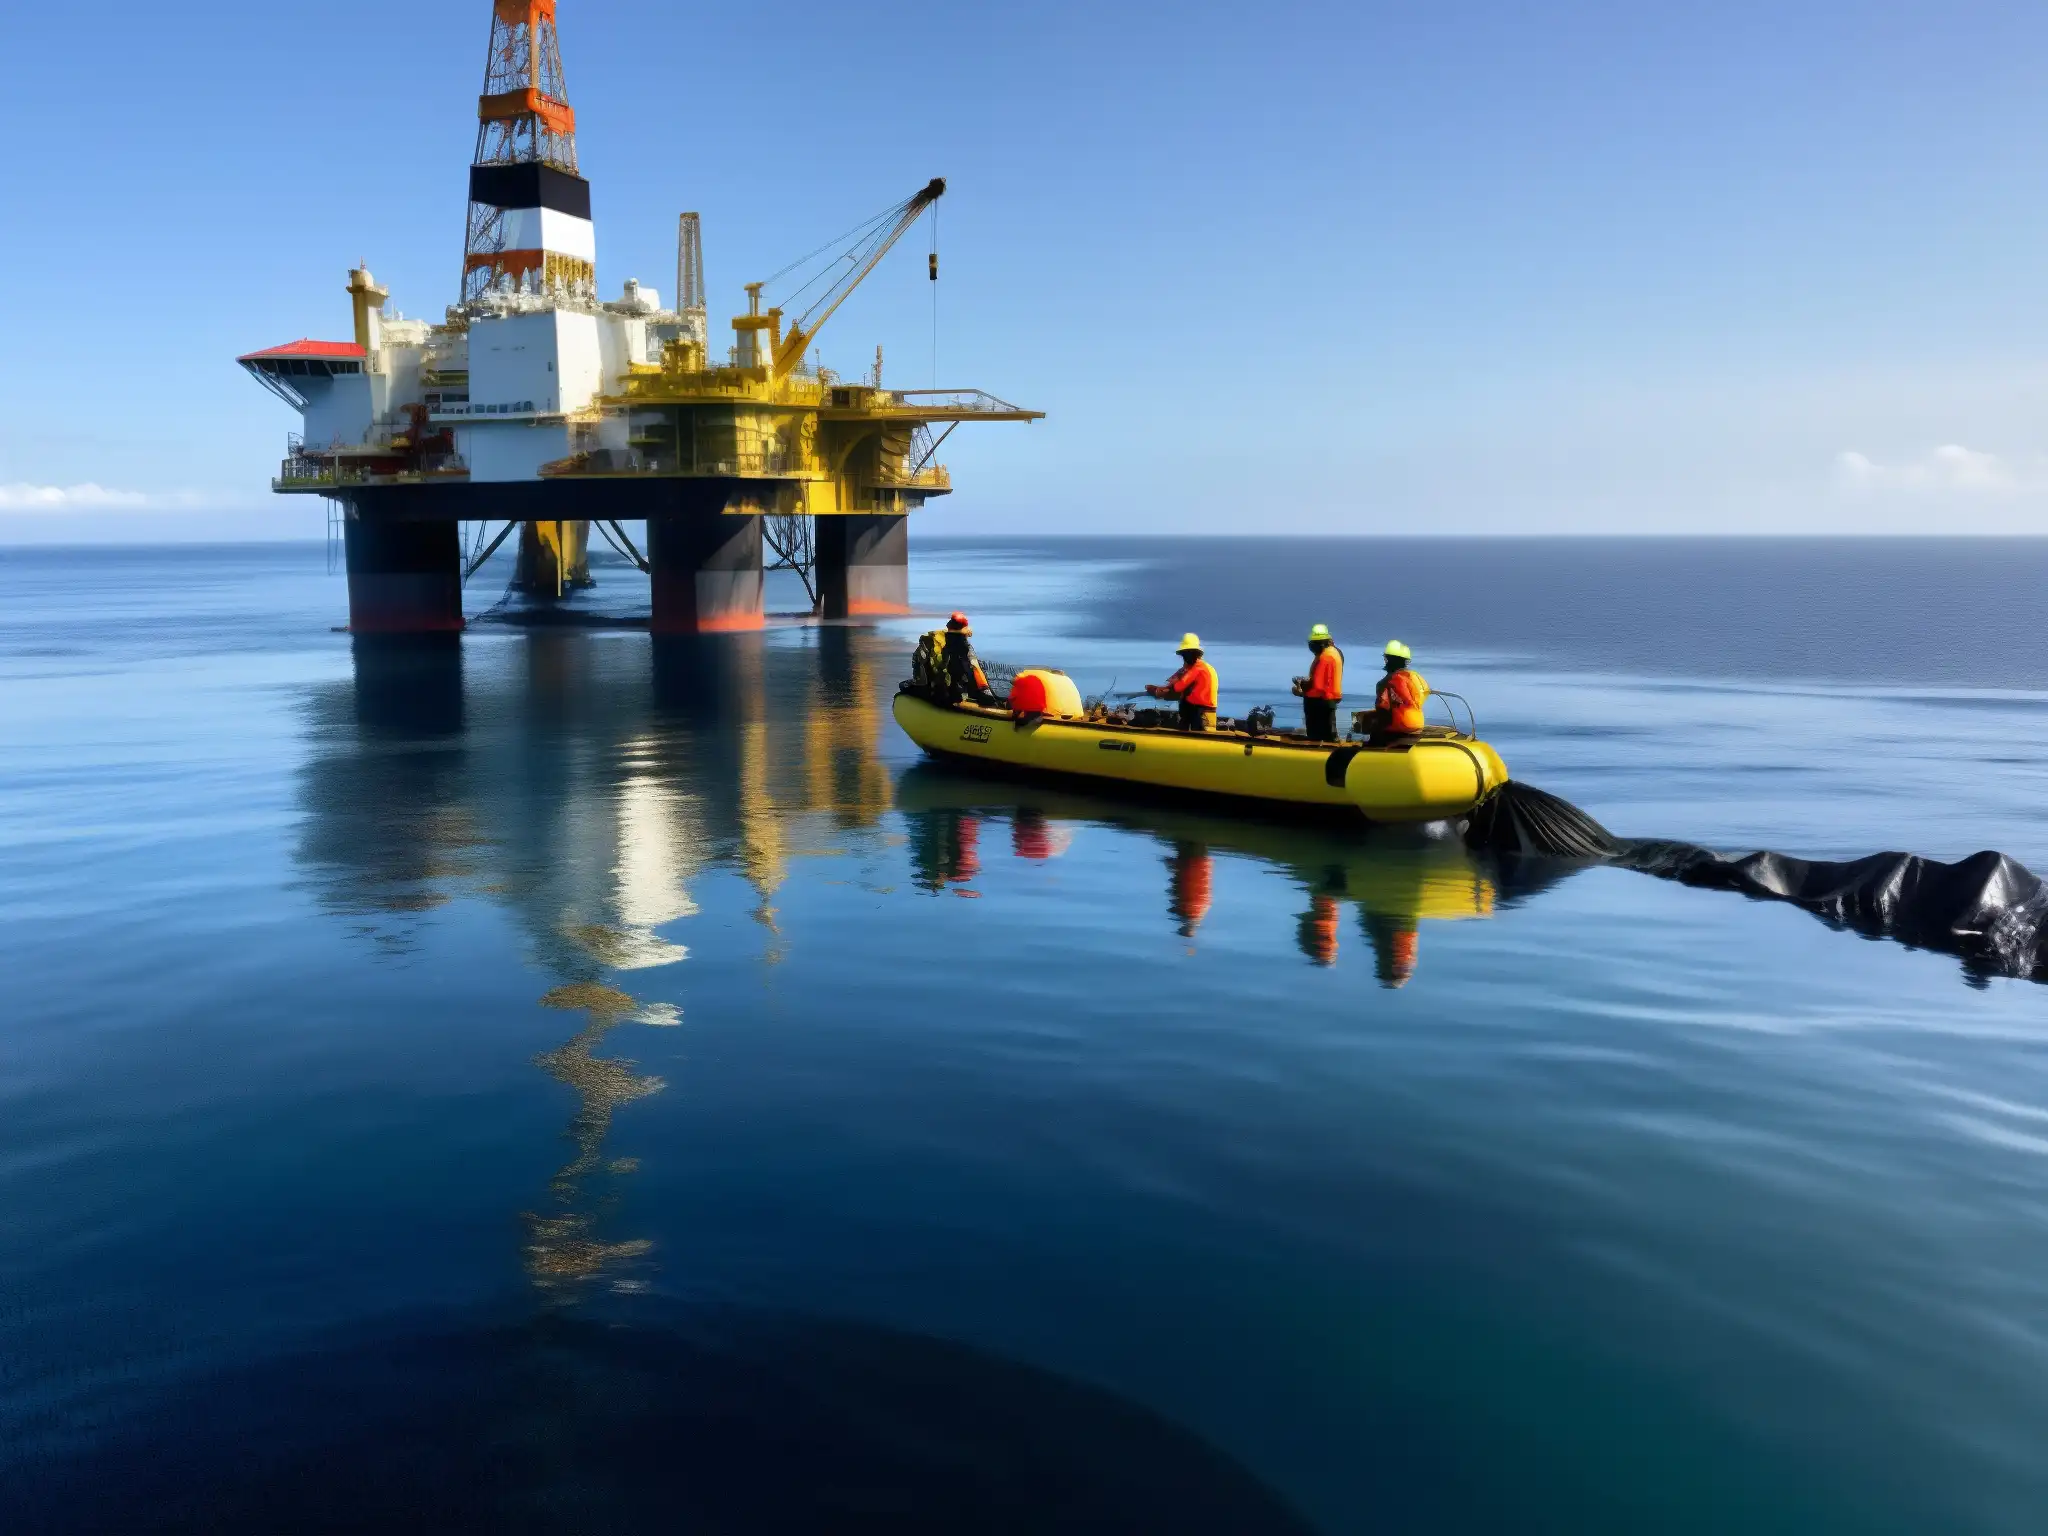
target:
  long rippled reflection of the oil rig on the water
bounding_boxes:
[297,627,893,1300]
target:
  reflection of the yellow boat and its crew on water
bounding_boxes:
[897,764,1526,987]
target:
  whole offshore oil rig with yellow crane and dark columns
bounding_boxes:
[238,0,1042,635]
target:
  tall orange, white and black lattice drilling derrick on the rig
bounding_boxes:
[463,0,598,303]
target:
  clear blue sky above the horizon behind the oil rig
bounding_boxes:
[0,0,2048,539]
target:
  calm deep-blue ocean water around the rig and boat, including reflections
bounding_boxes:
[0,541,2048,1532]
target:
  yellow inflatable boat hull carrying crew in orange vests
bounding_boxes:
[895,674,1507,821]
